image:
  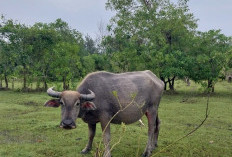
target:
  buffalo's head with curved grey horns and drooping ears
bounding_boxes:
[44,87,96,129]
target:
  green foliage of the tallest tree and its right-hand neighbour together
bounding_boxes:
[102,0,231,89]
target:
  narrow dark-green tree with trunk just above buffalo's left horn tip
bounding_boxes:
[27,23,58,90]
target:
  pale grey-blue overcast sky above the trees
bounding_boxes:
[0,0,232,37]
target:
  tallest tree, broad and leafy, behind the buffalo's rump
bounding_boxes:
[103,0,197,90]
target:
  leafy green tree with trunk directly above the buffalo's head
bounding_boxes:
[49,19,88,89]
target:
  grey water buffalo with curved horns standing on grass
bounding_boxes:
[45,70,164,157]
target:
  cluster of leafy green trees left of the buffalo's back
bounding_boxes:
[0,16,85,90]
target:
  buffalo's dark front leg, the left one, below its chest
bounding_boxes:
[81,123,96,154]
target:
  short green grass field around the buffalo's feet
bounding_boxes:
[0,81,232,157]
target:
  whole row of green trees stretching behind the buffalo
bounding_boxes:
[0,0,232,90]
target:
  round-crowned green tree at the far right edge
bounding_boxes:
[188,30,230,92]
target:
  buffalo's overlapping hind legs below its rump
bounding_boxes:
[143,106,158,157]
